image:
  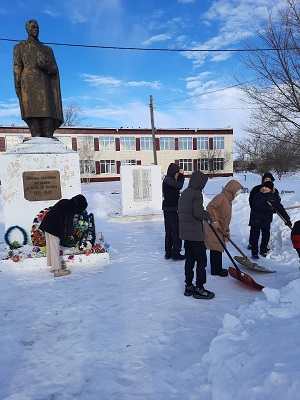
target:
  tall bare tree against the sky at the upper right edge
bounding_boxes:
[241,0,300,148]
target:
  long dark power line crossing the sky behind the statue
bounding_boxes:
[0,38,298,53]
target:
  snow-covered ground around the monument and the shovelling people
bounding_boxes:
[0,174,300,400]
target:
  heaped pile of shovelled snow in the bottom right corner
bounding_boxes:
[208,279,300,400]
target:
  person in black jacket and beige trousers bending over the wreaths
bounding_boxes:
[39,194,87,277]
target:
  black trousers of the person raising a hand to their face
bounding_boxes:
[164,211,182,257]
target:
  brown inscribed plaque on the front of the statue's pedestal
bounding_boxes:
[23,171,61,201]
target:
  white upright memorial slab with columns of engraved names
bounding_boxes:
[120,165,162,216]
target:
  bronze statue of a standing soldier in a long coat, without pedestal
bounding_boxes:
[14,19,63,138]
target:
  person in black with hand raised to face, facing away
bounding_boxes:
[162,163,185,261]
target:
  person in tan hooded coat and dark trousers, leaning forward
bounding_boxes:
[205,180,243,277]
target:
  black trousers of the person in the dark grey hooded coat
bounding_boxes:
[184,240,207,288]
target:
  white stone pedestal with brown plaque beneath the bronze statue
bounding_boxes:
[0,138,81,244]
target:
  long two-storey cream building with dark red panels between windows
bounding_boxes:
[0,126,233,182]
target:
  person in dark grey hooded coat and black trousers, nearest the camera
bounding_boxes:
[178,171,215,299]
